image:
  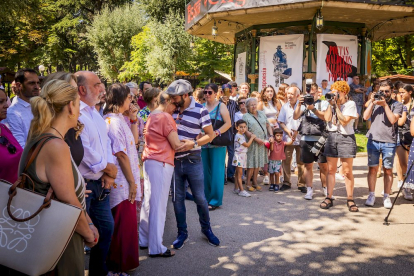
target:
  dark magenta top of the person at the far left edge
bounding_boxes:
[0,124,23,183]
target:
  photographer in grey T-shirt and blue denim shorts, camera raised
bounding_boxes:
[364,80,403,209]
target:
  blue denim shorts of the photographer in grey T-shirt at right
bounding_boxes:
[367,139,397,169]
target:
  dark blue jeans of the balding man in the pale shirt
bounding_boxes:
[86,179,114,276]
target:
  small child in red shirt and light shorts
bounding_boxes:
[268,128,295,193]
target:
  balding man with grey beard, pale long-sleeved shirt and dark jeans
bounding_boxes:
[75,71,118,276]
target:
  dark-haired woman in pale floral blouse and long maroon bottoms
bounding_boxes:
[104,83,142,273]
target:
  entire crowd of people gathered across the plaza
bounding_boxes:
[0,69,414,275]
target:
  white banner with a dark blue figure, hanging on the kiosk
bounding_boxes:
[259,34,304,91]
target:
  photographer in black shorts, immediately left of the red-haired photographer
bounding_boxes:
[293,79,329,200]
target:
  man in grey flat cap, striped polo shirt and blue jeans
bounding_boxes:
[166,80,220,249]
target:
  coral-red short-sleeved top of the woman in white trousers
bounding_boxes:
[142,112,177,166]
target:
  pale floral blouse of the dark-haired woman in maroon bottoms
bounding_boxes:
[104,113,142,209]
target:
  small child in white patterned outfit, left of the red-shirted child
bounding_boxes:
[233,120,256,197]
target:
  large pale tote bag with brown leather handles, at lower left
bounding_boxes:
[0,136,82,275]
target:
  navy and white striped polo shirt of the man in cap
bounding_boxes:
[173,97,211,158]
